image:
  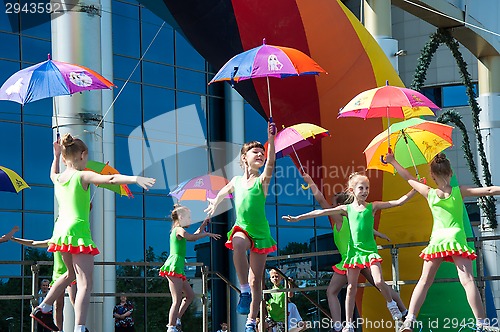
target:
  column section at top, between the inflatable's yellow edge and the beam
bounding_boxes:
[363,0,398,72]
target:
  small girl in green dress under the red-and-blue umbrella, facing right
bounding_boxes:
[159,204,220,332]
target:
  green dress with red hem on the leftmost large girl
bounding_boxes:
[48,171,99,255]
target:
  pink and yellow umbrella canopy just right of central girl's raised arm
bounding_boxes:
[274,123,330,158]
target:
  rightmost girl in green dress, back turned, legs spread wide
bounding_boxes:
[386,153,500,332]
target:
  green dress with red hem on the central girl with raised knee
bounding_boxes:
[226,176,276,254]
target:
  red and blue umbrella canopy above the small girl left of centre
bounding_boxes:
[169,174,231,201]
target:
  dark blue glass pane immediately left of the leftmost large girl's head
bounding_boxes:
[23,125,53,184]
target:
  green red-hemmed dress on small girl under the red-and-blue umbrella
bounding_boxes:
[158,226,187,280]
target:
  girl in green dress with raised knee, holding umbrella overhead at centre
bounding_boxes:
[205,123,276,332]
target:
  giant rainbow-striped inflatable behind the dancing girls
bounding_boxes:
[141,0,488,331]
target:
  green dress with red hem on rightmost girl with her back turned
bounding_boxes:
[420,186,476,262]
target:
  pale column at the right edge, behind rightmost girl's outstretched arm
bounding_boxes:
[478,55,500,320]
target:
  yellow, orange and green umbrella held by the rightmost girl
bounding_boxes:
[364,118,453,177]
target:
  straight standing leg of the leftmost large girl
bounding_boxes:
[73,254,94,325]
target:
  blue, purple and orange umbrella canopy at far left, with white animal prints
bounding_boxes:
[0,57,114,105]
